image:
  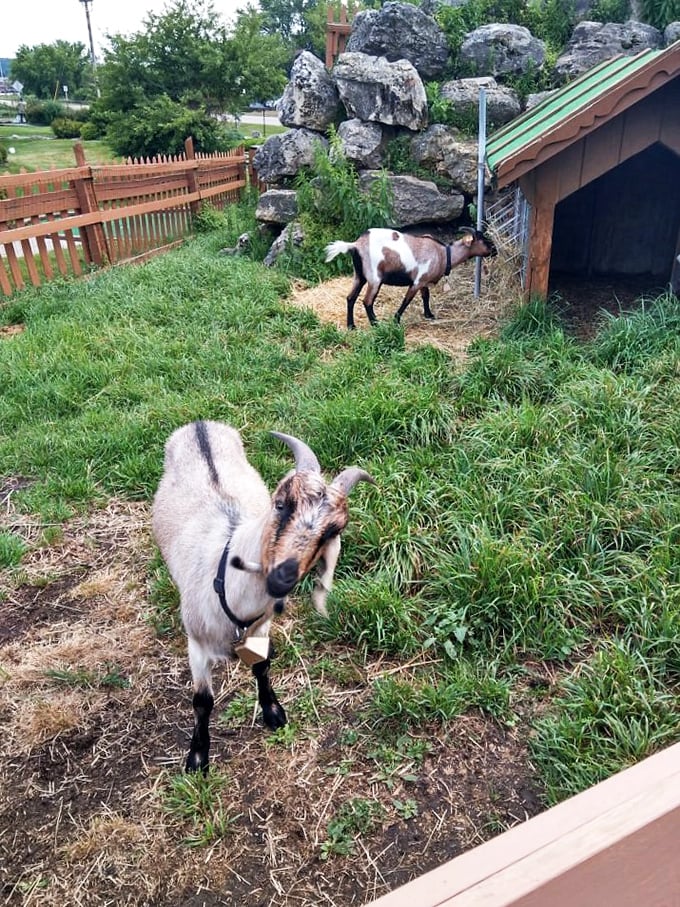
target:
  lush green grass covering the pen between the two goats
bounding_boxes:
[0,223,680,808]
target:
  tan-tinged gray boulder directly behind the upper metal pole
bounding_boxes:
[411,123,489,196]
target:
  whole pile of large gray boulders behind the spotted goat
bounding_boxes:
[253,0,680,252]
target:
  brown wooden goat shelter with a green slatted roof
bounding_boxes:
[487,41,680,297]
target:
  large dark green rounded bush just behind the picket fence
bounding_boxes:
[106,95,237,157]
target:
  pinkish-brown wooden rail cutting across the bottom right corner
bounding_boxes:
[371,744,680,907]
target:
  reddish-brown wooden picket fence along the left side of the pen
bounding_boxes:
[0,139,255,296]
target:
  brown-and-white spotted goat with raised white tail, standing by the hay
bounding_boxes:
[325,227,496,329]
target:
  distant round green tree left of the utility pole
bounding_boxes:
[11,41,93,98]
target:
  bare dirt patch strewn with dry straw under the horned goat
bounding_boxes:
[0,496,540,907]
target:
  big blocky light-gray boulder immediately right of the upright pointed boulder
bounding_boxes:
[332,53,427,132]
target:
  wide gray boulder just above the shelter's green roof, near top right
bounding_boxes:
[555,19,663,82]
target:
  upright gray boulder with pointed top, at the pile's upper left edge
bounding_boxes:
[278,50,340,132]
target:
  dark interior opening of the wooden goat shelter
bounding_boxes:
[550,143,680,291]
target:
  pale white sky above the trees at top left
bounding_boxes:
[0,0,246,58]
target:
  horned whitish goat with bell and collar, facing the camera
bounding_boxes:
[152,421,373,771]
